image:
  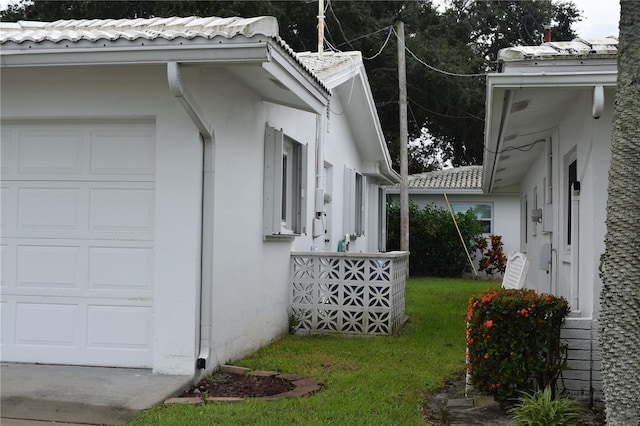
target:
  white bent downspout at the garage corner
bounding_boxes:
[167,62,215,369]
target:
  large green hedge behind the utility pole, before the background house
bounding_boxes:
[387,203,482,278]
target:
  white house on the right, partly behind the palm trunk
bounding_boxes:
[483,38,617,399]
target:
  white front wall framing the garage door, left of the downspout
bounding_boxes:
[2,67,202,374]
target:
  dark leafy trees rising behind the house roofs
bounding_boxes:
[0,0,580,173]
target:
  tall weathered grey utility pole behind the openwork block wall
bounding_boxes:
[396,21,409,251]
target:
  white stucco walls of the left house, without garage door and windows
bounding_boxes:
[2,59,390,375]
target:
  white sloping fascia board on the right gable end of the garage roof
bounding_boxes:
[262,49,330,114]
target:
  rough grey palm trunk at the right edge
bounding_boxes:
[600,1,640,426]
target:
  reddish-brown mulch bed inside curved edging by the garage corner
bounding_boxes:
[180,371,295,398]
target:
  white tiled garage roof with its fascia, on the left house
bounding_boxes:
[0,16,330,112]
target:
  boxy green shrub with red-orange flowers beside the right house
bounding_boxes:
[465,288,570,403]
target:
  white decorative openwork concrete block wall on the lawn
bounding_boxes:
[291,252,409,335]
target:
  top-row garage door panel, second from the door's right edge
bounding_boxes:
[18,130,82,175]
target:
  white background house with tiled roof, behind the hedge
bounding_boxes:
[386,166,520,266]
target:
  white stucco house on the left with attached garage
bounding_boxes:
[0,17,399,375]
